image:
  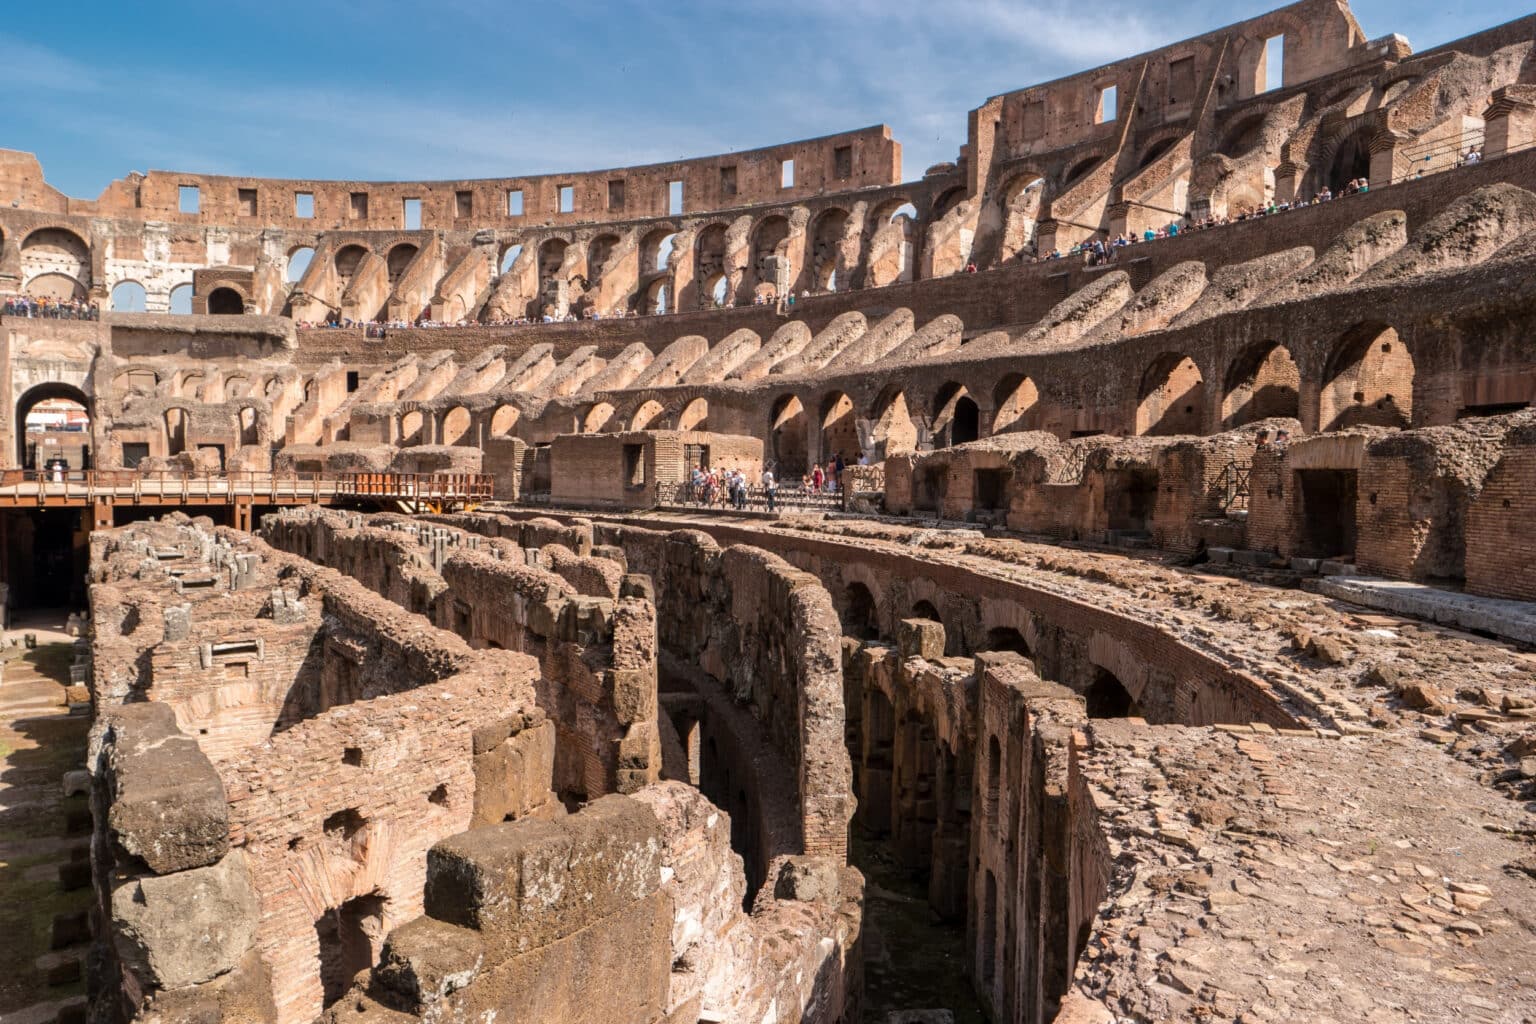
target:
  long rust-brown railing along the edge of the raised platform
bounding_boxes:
[0,470,495,505]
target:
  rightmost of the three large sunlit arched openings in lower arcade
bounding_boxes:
[1318,322,1413,430]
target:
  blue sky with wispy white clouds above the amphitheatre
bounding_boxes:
[0,0,1528,198]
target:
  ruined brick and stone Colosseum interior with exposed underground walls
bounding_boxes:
[0,0,1536,1024]
